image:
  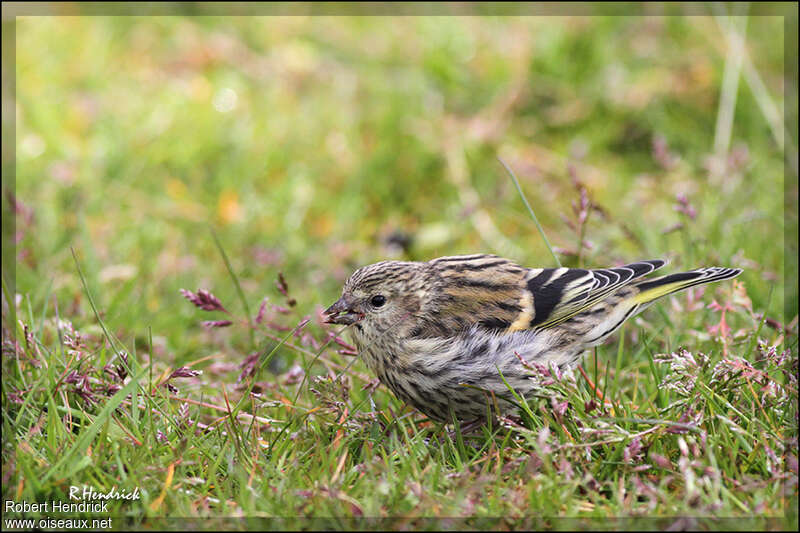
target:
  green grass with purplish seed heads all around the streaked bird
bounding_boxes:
[2,10,798,529]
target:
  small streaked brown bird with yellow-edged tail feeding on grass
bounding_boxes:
[324,254,742,423]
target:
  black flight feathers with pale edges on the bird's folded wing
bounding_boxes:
[514,259,665,329]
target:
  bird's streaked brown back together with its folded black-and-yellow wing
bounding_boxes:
[428,254,664,337]
